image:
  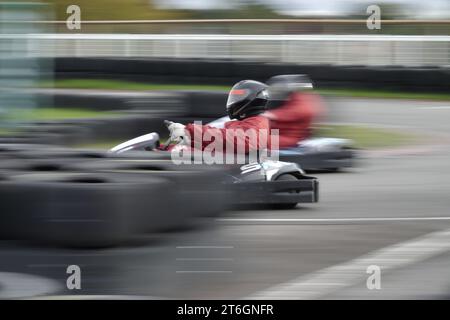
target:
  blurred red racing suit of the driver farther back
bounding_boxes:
[263,92,324,149]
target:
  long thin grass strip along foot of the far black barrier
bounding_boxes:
[40,79,450,101]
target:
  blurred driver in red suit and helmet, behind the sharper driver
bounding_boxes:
[263,74,324,149]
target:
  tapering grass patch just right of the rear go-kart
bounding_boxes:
[314,125,417,149]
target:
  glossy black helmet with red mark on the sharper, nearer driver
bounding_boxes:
[227,80,269,120]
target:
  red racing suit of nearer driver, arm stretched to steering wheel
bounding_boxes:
[185,115,270,154]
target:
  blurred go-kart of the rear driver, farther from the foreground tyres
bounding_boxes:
[208,116,355,171]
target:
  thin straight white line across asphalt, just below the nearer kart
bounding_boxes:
[216,217,450,224]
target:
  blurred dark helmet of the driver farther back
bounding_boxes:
[267,74,313,109]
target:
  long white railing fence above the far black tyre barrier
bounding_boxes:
[0,34,450,66]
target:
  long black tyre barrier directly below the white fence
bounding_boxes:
[49,58,450,92]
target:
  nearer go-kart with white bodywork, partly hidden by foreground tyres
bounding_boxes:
[109,123,319,209]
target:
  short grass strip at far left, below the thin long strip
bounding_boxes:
[9,108,113,121]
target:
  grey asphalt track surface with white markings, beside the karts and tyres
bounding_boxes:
[0,98,450,299]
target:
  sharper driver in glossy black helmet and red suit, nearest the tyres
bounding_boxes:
[168,80,270,154]
